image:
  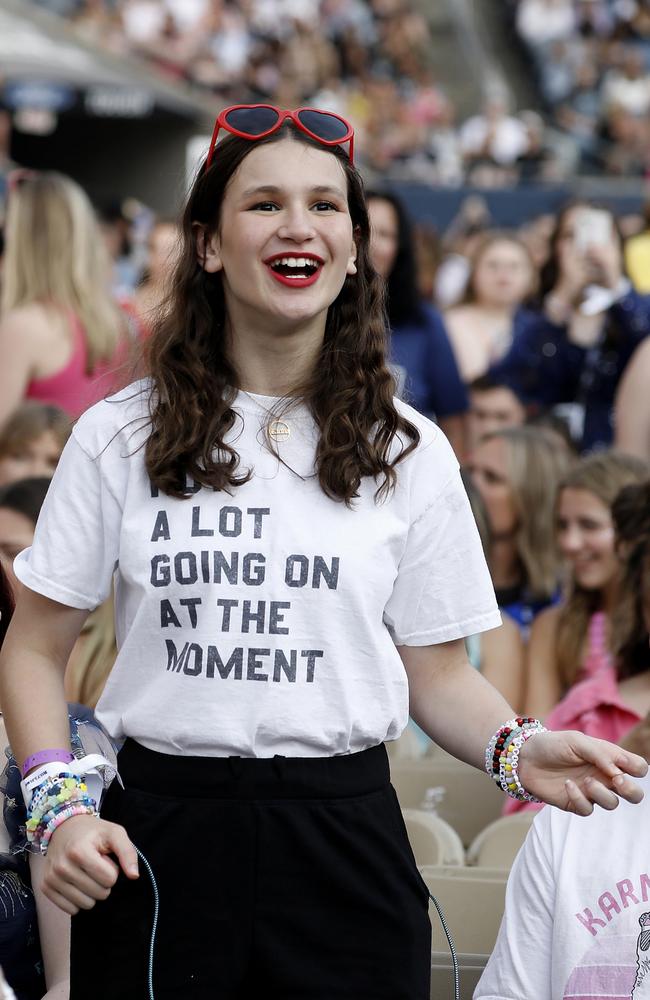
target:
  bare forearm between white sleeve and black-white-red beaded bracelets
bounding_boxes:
[401,643,517,768]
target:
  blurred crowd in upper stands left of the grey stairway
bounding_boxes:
[20,0,588,187]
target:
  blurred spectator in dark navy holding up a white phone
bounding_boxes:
[492,204,650,450]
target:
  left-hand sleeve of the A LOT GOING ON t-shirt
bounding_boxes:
[14,432,121,611]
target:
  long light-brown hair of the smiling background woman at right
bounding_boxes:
[556,451,648,688]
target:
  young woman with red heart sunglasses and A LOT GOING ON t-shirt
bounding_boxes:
[0,106,646,1000]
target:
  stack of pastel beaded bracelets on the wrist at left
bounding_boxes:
[25,770,99,854]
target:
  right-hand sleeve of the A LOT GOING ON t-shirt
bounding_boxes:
[384,430,501,646]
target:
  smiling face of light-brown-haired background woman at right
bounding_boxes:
[557,487,619,590]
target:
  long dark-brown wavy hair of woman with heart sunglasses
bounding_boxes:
[145,124,420,504]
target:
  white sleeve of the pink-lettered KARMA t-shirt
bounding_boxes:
[474,806,555,1000]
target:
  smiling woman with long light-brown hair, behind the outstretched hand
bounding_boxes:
[525,451,649,720]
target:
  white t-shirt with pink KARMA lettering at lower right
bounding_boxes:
[474,776,650,1000]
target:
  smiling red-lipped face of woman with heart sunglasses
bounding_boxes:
[199,139,356,340]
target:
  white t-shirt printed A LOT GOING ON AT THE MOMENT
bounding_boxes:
[15,383,500,757]
